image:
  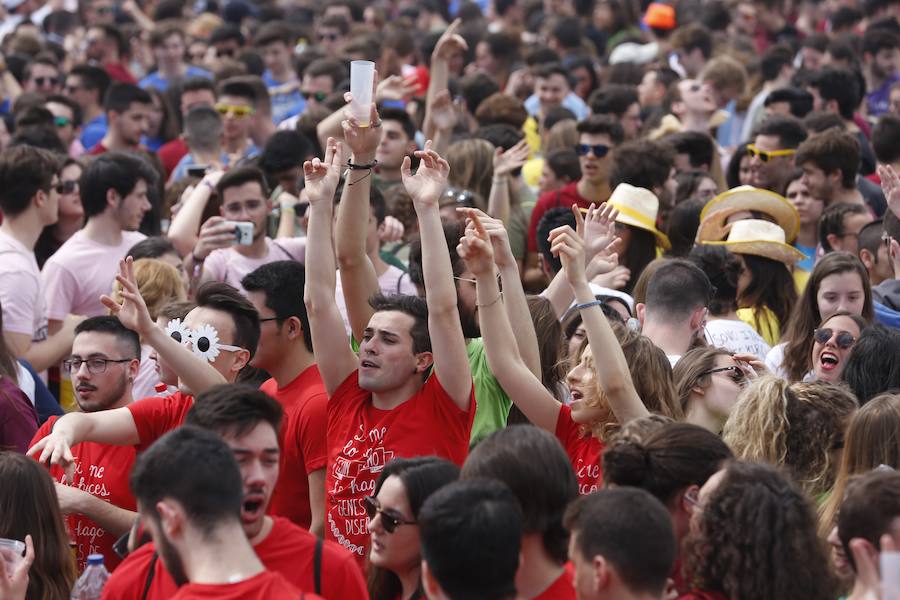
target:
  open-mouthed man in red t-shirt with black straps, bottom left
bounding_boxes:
[103,385,366,600]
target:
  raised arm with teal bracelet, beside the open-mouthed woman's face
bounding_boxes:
[550,219,650,425]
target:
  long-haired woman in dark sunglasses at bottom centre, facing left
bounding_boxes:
[362,456,459,600]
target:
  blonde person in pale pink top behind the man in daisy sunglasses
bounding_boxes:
[113,258,187,398]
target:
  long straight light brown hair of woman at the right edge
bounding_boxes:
[819,394,900,538]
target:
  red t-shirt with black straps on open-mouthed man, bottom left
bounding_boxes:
[103,518,368,600]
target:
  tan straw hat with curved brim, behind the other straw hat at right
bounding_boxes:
[697,185,800,243]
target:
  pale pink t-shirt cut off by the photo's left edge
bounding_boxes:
[0,231,47,342]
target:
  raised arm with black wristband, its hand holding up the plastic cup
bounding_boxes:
[335,104,382,340]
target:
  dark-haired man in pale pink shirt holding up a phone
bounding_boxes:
[185,167,306,290]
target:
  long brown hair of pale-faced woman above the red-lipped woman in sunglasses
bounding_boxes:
[782,252,875,381]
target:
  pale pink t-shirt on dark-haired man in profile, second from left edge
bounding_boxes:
[41,229,146,321]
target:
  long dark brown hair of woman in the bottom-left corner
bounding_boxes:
[0,452,78,600]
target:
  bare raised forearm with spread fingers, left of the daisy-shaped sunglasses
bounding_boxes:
[100,256,227,395]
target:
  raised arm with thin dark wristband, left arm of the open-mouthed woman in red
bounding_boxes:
[457,211,560,433]
